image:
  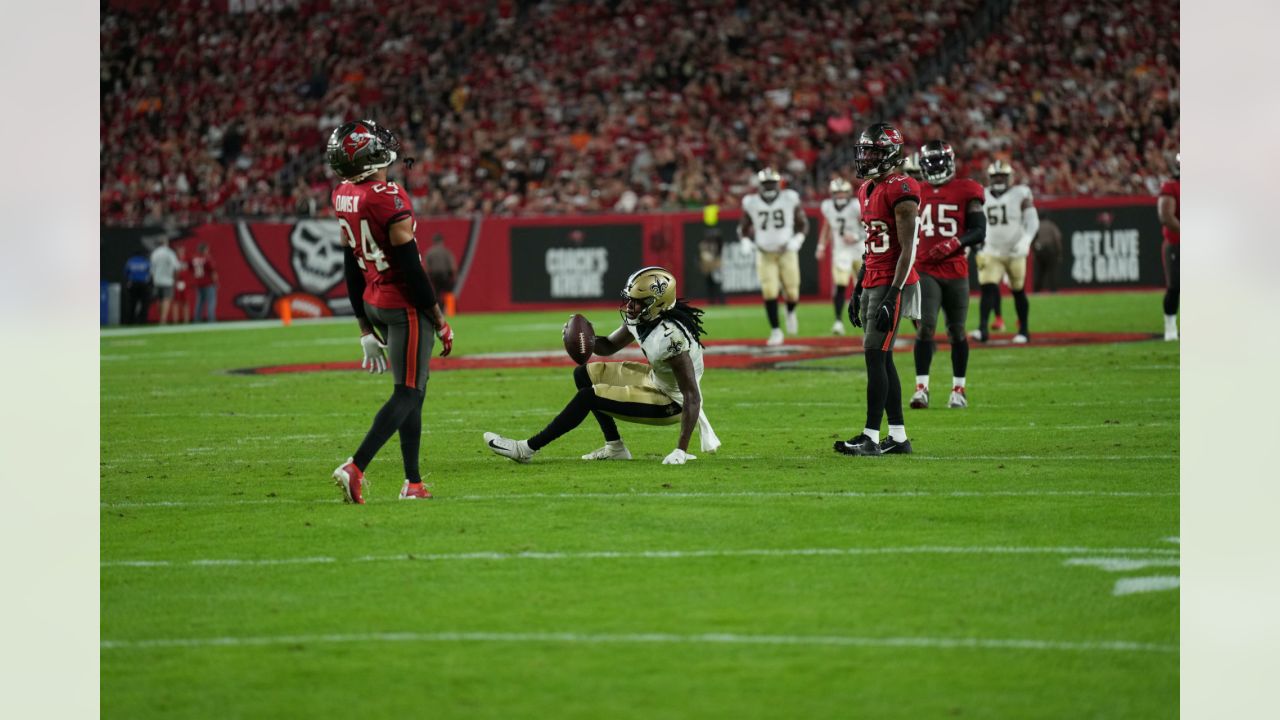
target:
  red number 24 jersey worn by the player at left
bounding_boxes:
[333,181,421,307]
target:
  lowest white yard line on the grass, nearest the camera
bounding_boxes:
[99,632,1178,655]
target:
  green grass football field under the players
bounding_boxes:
[101,288,1179,717]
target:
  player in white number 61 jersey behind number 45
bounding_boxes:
[973,160,1039,343]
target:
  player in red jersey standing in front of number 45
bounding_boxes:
[835,123,920,456]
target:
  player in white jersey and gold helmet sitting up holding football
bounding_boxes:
[484,266,719,465]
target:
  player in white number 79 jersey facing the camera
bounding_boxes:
[737,168,809,345]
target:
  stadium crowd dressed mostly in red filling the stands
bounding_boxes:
[101,0,1178,224]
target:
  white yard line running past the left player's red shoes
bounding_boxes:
[99,483,1179,510]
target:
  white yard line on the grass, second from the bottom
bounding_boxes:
[99,546,1178,568]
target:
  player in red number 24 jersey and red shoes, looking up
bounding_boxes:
[325,120,453,505]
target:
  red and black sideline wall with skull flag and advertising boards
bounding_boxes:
[100,197,1164,320]
